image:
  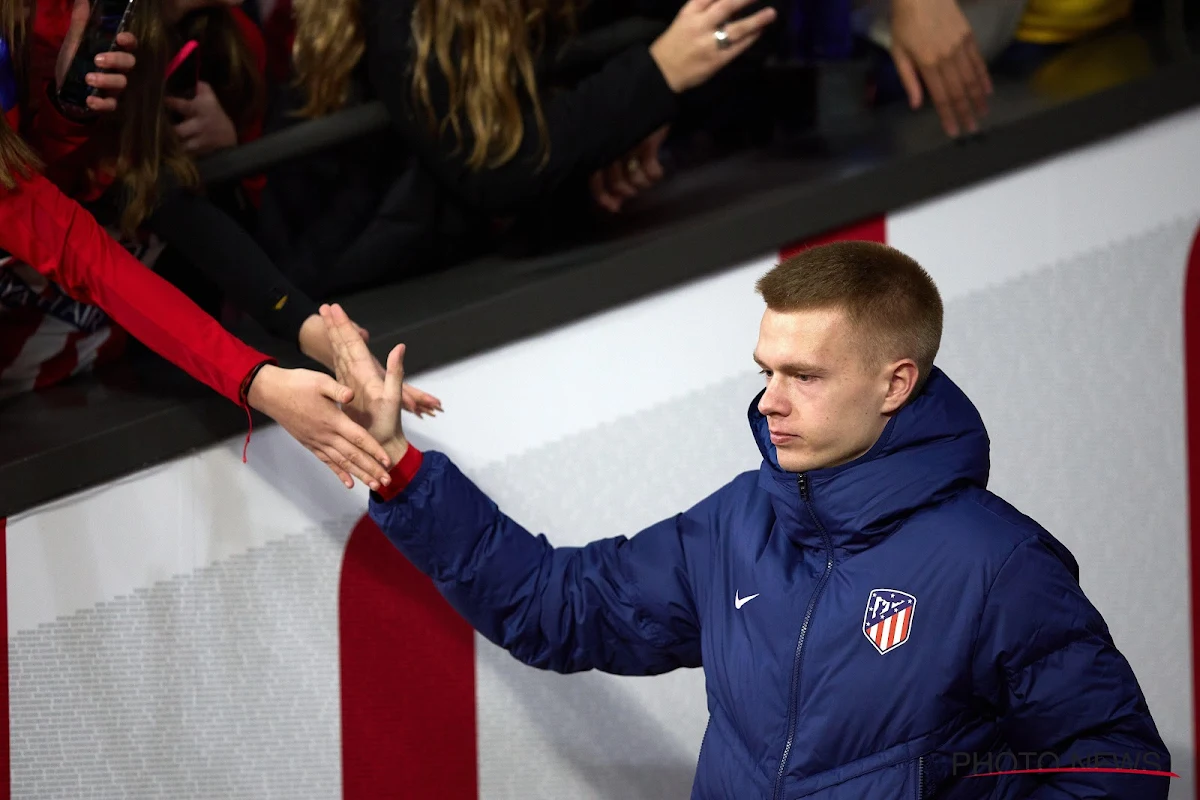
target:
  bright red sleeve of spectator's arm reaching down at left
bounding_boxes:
[0,171,271,405]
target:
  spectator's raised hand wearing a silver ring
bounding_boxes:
[650,0,775,92]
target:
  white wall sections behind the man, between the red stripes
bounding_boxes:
[7,106,1200,800]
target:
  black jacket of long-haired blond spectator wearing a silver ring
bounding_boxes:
[259,0,678,299]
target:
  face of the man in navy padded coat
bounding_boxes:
[755,308,897,473]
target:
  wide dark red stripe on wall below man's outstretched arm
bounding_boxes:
[338,517,479,800]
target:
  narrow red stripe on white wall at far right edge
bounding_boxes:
[1183,220,1200,796]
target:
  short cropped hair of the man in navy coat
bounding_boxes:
[755,241,943,395]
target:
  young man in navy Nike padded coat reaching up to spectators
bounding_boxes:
[323,242,1170,800]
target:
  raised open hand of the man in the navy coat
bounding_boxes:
[320,303,408,463]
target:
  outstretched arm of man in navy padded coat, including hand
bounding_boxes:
[322,306,720,674]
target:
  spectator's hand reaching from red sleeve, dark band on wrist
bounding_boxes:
[246,367,396,491]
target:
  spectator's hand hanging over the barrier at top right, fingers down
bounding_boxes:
[892,0,991,137]
